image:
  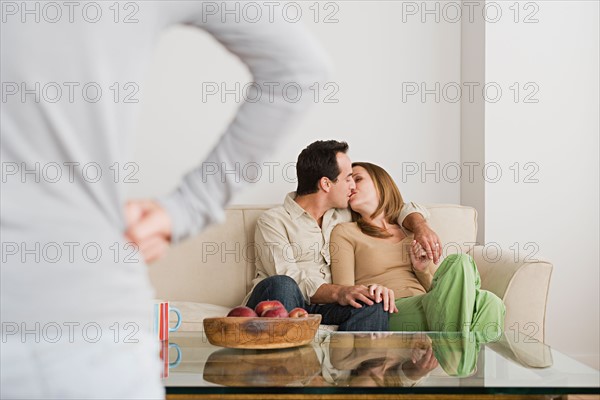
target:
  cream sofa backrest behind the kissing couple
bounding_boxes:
[149,204,477,307]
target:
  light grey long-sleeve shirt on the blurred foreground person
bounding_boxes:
[0,1,329,394]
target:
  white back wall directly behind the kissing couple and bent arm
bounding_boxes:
[129,2,460,204]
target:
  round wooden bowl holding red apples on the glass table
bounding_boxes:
[204,314,321,349]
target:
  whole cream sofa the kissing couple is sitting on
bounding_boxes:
[149,204,552,342]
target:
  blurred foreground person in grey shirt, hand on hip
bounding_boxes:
[0,1,329,399]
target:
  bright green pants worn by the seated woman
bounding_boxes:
[389,254,506,341]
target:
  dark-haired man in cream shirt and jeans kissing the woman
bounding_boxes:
[244,140,441,331]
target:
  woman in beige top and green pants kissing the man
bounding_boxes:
[330,162,505,340]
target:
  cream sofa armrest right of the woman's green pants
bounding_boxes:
[469,246,552,342]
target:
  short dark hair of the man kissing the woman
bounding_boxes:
[296,140,348,196]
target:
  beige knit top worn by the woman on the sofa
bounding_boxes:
[329,222,432,299]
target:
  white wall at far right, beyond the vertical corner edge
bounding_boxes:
[485,1,600,368]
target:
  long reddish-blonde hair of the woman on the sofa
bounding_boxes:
[352,162,404,238]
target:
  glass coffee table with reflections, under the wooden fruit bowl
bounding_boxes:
[162,332,600,399]
